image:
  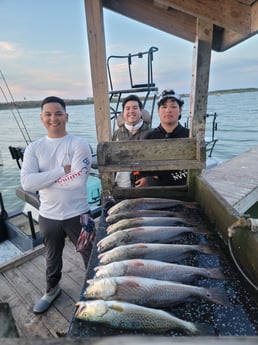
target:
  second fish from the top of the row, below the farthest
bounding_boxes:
[106,210,184,224]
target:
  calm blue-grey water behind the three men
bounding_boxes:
[0,92,258,213]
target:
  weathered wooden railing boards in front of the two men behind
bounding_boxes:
[97,138,206,197]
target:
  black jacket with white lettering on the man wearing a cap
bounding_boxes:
[140,123,189,186]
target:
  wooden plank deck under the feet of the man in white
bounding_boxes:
[0,240,85,338]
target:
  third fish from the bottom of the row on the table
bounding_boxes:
[94,259,225,283]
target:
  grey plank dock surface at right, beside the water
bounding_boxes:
[202,146,258,214]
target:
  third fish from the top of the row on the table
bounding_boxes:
[106,217,195,235]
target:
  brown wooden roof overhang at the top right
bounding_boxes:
[103,0,258,52]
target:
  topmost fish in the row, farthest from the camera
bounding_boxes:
[107,198,198,215]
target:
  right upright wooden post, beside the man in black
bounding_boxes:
[188,18,213,196]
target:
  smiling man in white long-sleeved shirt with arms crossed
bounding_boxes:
[21,96,92,313]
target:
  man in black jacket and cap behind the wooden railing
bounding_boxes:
[135,90,189,187]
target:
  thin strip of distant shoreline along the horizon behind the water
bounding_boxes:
[0,88,258,110]
